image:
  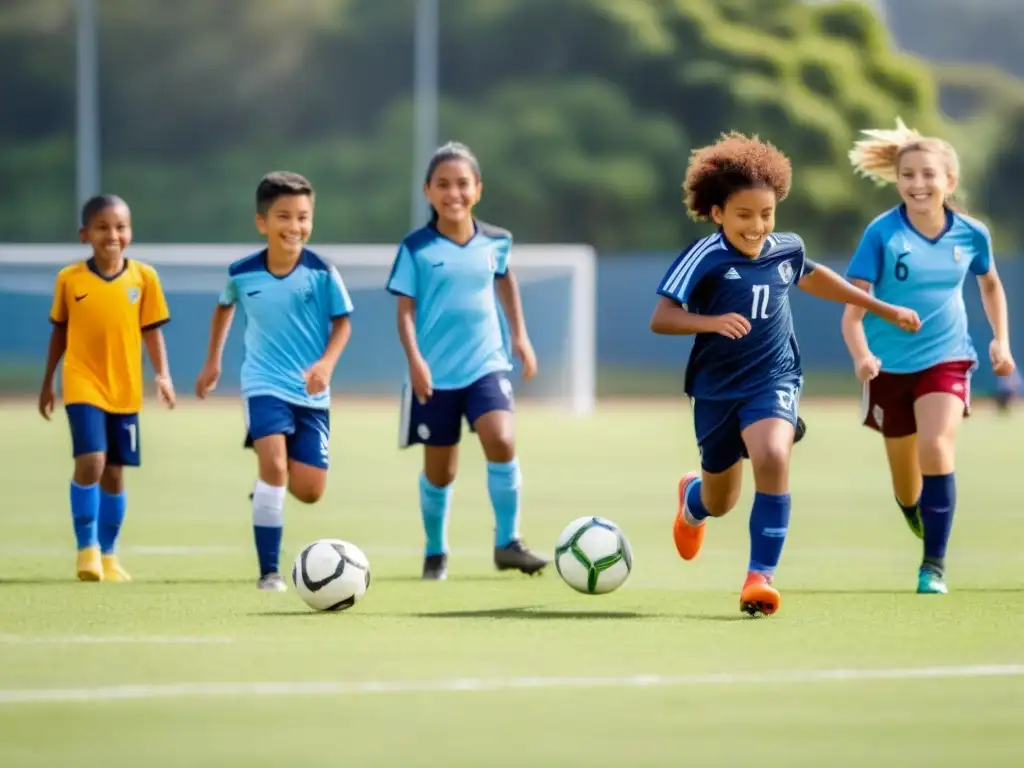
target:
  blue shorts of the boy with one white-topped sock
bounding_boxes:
[243,394,331,469]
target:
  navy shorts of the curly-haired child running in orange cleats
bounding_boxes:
[693,380,800,474]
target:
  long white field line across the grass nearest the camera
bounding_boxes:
[0,664,1024,705]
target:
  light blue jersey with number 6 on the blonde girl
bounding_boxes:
[847,205,992,374]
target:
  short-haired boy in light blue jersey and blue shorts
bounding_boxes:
[196,171,352,592]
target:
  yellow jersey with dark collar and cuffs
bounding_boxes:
[50,259,171,414]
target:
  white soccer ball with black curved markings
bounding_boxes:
[292,539,370,610]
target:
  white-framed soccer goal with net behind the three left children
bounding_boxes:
[0,244,596,414]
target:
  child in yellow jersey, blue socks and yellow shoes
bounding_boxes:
[39,195,174,582]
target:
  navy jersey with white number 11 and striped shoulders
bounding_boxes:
[657,232,814,400]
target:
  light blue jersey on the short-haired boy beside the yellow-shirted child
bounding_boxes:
[217,249,352,409]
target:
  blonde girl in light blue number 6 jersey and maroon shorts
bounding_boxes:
[843,121,1015,594]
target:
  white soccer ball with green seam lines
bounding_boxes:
[555,516,633,595]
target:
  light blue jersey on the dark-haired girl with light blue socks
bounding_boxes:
[387,221,512,389]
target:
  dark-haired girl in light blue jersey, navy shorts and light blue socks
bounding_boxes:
[387,143,548,580]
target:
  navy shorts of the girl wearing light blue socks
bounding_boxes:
[398,373,514,447]
